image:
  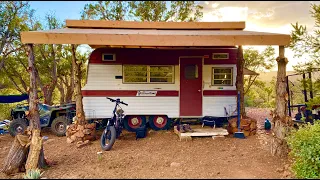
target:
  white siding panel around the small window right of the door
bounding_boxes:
[203,64,237,90]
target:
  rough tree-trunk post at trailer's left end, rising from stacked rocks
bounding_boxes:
[72,44,85,125]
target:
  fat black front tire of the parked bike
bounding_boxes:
[100,126,116,151]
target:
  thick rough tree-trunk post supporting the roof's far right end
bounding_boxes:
[271,46,291,156]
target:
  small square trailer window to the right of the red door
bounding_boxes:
[212,67,233,86]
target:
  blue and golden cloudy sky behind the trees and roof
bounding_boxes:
[30,1,320,71]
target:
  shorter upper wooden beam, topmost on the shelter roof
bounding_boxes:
[66,20,246,30]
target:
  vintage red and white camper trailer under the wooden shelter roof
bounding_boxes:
[82,46,238,129]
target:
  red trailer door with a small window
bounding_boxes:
[180,57,202,116]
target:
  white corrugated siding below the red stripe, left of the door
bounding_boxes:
[83,97,179,118]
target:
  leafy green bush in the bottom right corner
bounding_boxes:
[287,121,320,179]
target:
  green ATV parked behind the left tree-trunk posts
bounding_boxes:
[9,103,76,137]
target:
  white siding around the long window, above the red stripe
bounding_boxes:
[82,64,180,91]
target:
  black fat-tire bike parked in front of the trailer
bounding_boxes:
[100,97,128,151]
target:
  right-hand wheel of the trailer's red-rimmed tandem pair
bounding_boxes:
[149,115,171,131]
